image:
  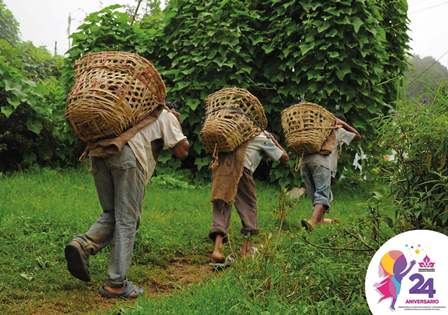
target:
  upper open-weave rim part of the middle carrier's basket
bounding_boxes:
[205,87,268,130]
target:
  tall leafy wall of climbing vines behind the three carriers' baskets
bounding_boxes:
[67,0,408,180]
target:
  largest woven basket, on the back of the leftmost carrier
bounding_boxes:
[65,51,166,142]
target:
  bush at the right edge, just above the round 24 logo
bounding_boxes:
[381,95,448,232]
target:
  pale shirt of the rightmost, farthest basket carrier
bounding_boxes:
[302,128,356,177]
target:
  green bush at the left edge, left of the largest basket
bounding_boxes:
[0,39,75,172]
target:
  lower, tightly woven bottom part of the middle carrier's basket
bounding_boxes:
[200,109,261,152]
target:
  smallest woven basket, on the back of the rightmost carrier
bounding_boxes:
[281,102,336,154]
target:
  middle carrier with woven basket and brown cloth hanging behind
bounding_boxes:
[201,88,288,266]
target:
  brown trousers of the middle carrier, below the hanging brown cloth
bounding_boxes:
[208,168,258,241]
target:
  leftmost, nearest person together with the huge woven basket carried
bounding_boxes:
[65,52,189,298]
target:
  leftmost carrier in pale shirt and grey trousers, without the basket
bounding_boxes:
[65,109,189,298]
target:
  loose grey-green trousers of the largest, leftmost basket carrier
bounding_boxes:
[75,145,145,287]
